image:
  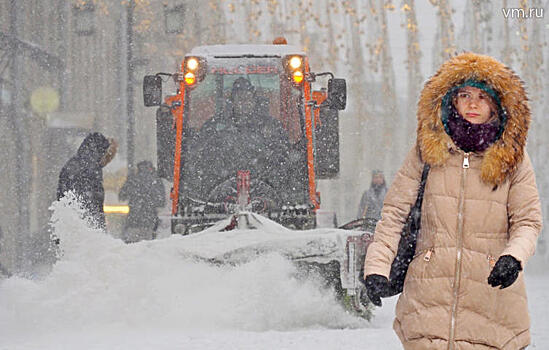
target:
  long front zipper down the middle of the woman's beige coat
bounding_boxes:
[448,153,469,350]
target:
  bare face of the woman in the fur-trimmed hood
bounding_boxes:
[455,86,494,124]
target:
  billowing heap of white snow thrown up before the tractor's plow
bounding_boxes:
[0,200,364,339]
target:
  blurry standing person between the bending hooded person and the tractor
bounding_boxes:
[118,160,166,243]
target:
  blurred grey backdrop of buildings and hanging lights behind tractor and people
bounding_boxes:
[0,0,549,271]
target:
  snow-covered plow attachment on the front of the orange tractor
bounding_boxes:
[171,212,371,319]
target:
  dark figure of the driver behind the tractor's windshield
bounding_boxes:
[188,77,290,200]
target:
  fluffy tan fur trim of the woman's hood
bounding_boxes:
[417,53,531,185]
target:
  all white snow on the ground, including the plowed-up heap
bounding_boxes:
[0,200,549,350]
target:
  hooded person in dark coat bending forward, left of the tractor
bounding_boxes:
[57,132,117,230]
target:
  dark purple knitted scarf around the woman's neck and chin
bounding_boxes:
[448,108,499,152]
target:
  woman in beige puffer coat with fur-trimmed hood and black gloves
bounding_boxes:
[364,53,542,350]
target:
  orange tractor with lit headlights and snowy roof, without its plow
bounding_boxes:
[143,44,347,234]
